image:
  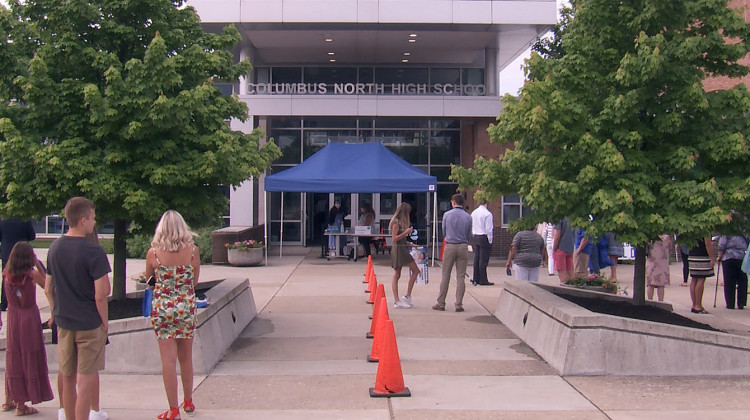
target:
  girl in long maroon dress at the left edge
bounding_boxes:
[0,242,54,416]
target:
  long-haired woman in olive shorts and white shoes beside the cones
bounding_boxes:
[388,203,419,309]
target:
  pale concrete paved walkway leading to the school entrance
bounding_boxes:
[0,247,750,420]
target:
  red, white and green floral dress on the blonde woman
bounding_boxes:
[150,247,195,340]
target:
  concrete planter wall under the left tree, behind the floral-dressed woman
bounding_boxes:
[0,278,258,375]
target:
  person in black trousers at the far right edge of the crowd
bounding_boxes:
[717,235,747,309]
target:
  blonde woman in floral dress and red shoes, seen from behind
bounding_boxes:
[146,210,201,420]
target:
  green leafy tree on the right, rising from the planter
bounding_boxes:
[453,0,750,303]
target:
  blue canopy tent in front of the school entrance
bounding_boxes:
[264,142,437,263]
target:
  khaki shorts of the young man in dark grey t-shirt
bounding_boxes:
[57,326,107,376]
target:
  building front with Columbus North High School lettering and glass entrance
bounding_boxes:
[187,0,557,255]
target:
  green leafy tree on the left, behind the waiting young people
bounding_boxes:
[0,0,280,298]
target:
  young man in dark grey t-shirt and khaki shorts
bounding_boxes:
[44,197,112,420]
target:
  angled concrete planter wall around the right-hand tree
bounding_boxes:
[495,281,750,376]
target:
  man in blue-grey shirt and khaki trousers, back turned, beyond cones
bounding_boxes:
[432,194,471,312]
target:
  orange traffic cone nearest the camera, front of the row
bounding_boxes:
[370,319,411,397]
